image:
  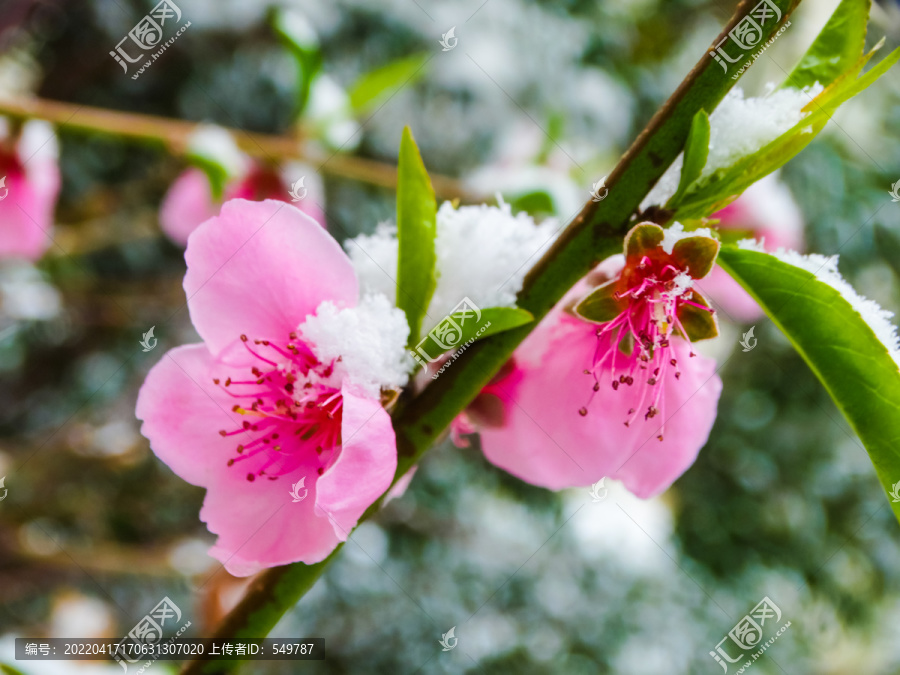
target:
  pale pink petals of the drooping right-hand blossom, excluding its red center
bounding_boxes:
[481,311,722,497]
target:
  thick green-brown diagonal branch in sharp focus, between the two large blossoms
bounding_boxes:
[182,0,801,675]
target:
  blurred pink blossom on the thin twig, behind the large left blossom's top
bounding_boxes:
[159,164,325,245]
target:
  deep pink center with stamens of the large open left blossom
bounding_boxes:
[213,333,344,481]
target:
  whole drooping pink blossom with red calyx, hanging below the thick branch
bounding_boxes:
[464,226,722,498]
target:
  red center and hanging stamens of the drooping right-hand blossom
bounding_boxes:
[578,256,710,440]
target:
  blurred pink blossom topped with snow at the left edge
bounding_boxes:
[0,119,60,260]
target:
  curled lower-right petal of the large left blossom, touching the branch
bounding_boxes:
[316,387,397,541]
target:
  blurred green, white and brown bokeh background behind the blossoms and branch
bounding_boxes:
[0,0,900,675]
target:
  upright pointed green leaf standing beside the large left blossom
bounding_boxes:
[397,127,437,345]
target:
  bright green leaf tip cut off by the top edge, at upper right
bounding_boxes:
[781,0,872,89]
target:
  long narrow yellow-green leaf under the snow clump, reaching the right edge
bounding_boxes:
[674,43,900,220]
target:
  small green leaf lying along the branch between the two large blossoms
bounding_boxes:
[414,303,534,364]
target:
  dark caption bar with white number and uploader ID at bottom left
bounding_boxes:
[16,637,325,667]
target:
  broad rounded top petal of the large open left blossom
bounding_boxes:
[184,199,359,354]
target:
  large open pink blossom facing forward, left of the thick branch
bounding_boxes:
[136,200,408,576]
